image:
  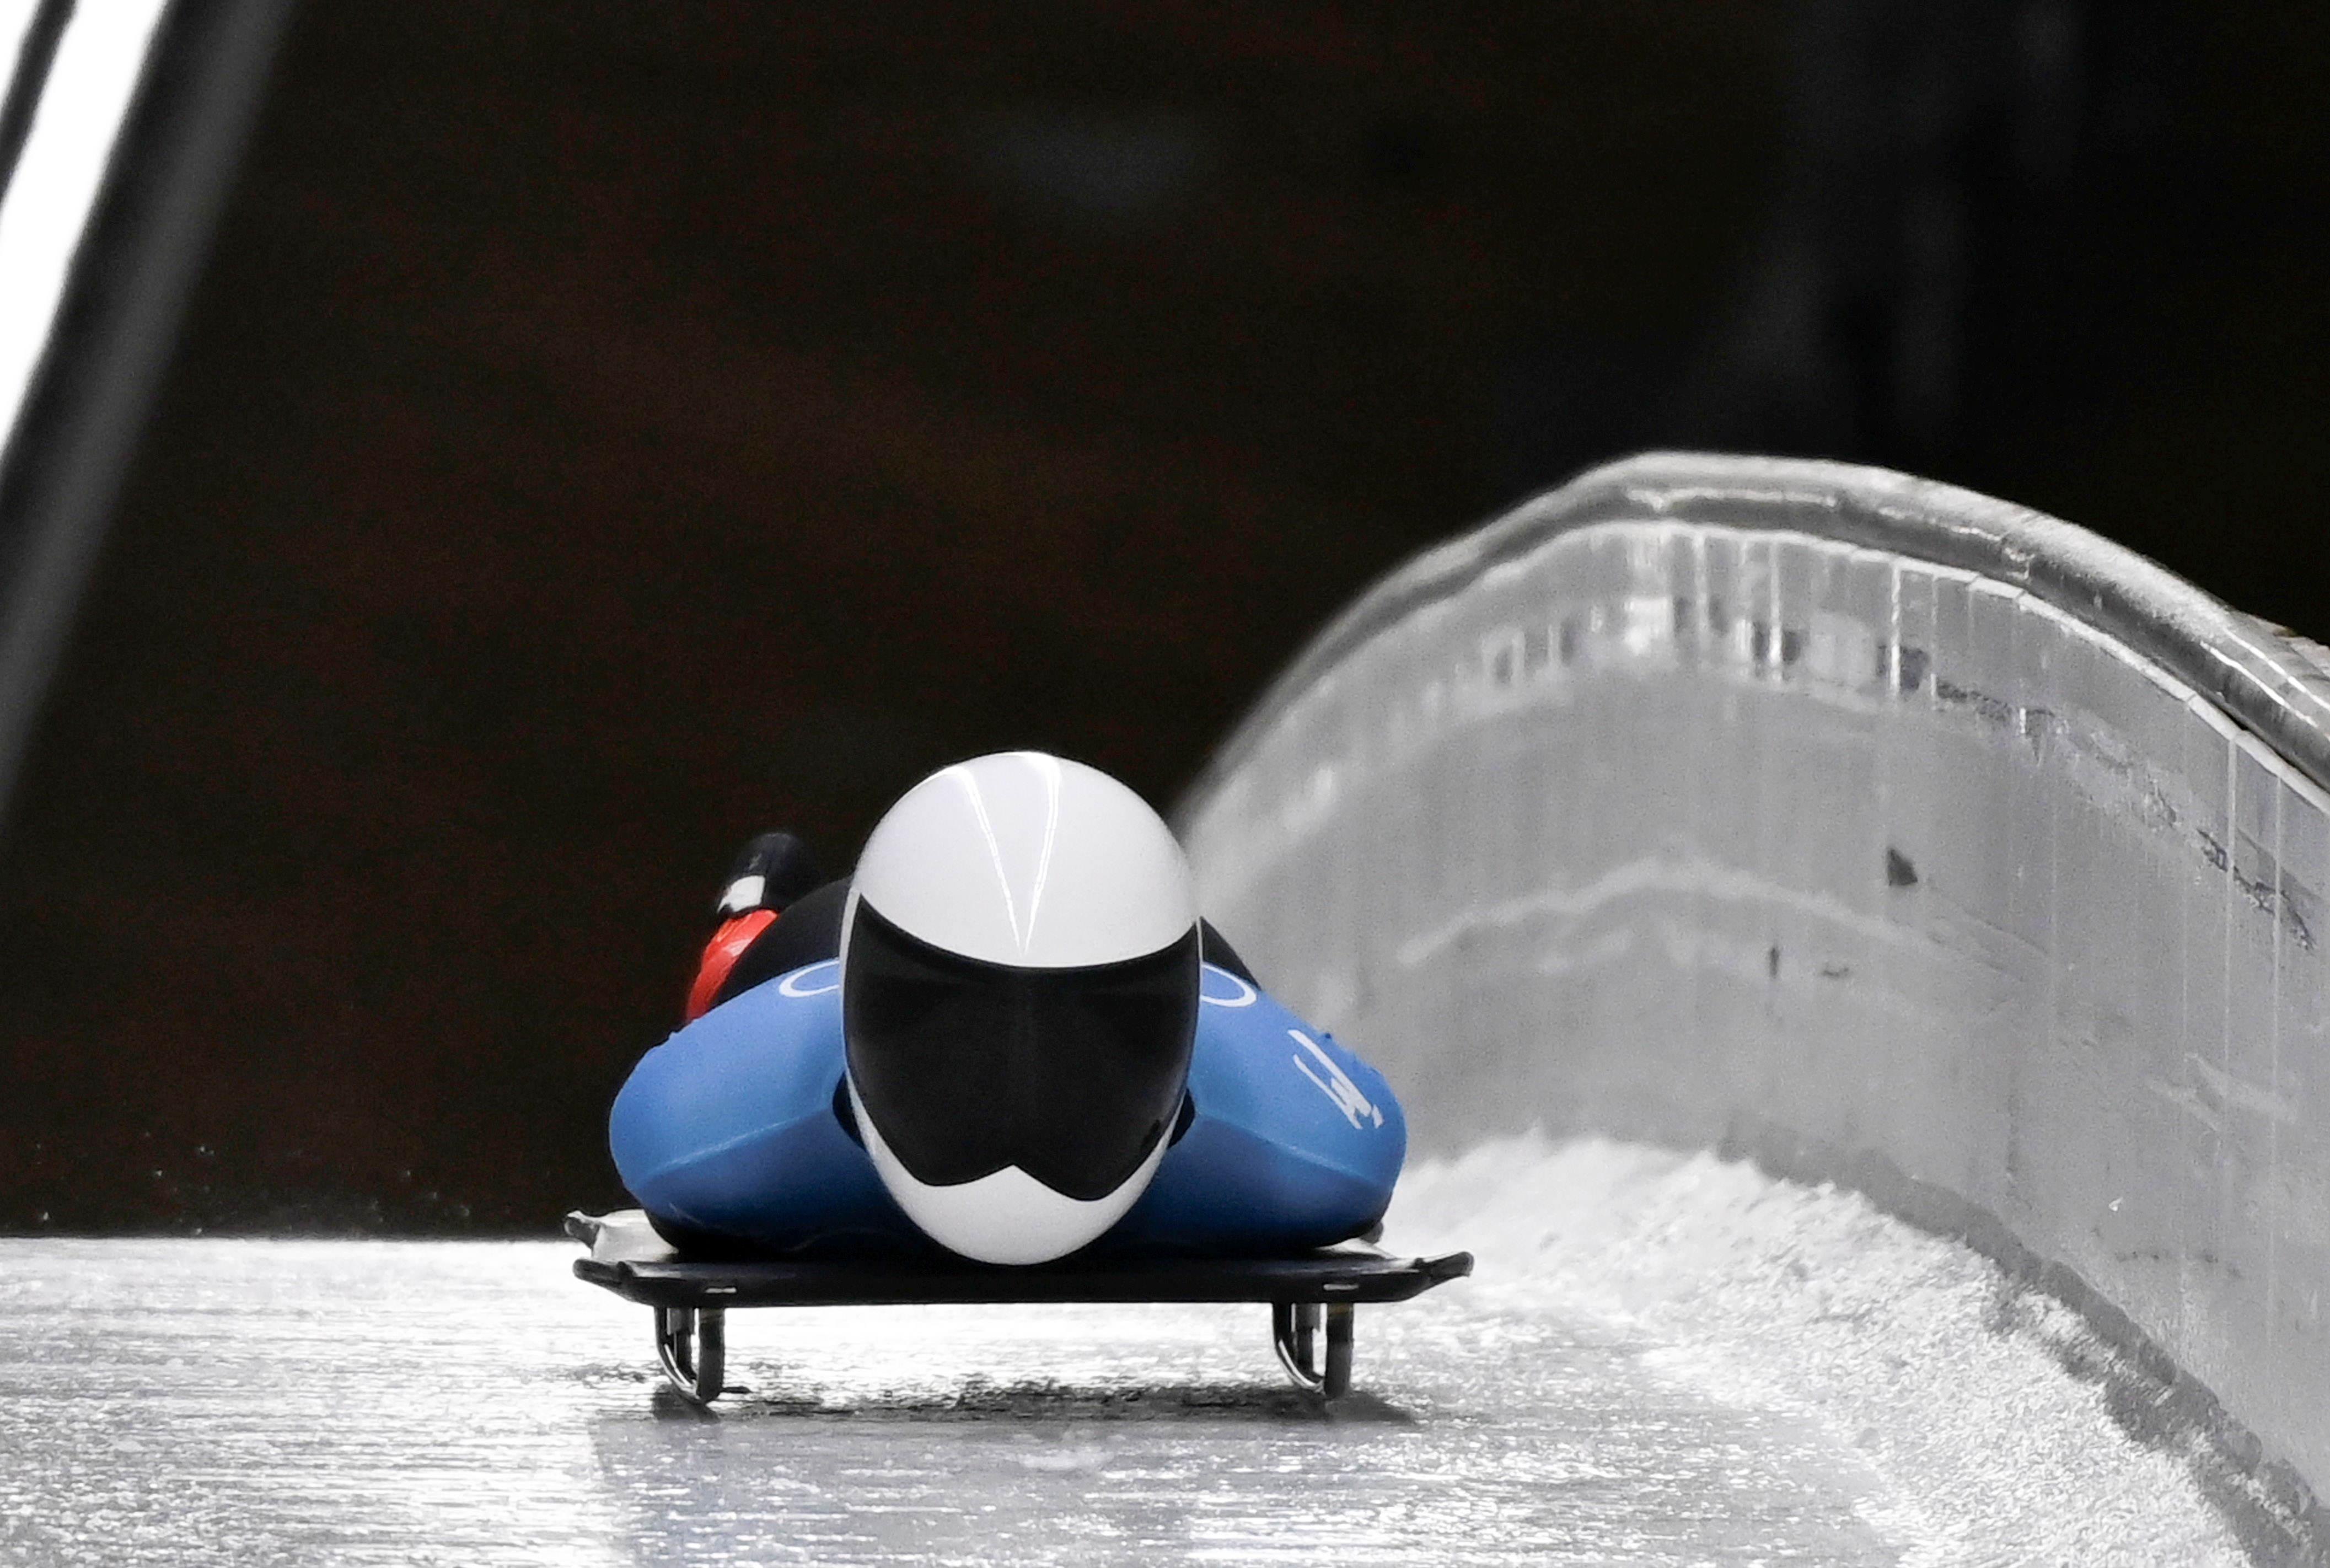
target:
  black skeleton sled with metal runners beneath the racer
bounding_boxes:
[566,1214,1473,1405]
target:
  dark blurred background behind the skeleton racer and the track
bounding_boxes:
[0,0,2330,1230]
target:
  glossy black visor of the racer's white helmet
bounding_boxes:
[841,899,1198,1202]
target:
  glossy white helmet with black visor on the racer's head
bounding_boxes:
[841,753,1198,1263]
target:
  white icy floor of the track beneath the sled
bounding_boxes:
[0,1139,2239,1566]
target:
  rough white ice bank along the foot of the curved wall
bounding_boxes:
[1386,1137,2246,1568]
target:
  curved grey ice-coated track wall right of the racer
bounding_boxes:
[1182,454,2330,1540]
